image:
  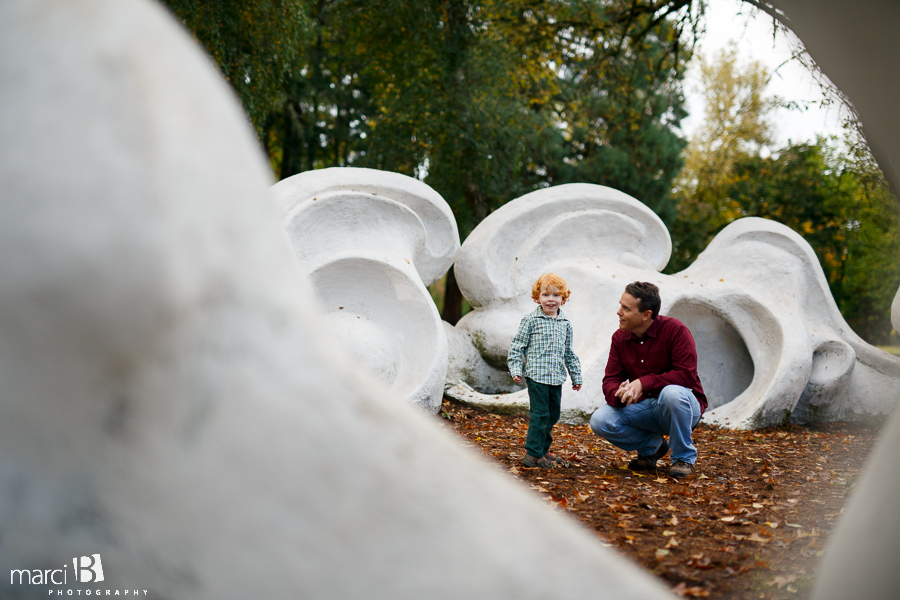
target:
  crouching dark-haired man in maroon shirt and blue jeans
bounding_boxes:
[591,281,707,477]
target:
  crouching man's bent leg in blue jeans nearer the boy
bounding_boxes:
[591,398,669,456]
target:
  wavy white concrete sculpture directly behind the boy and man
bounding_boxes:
[447,184,900,428]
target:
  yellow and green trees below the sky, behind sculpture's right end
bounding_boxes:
[666,52,900,344]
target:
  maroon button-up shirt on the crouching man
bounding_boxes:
[603,315,708,413]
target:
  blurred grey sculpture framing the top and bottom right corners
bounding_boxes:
[772,0,900,600]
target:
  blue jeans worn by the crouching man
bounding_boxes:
[591,385,700,464]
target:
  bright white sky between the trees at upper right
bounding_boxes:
[682,0,841,146]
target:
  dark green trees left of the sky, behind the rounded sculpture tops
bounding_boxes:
[165,0,702,322]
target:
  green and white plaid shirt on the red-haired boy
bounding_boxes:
[506,306,581,385]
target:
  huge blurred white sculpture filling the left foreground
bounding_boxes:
[0,0,670,600]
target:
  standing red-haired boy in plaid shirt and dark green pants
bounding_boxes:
[506,273,581,469]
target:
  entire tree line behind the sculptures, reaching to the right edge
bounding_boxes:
[161,0,900,341]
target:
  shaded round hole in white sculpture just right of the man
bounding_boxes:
[668,301,754,409]
